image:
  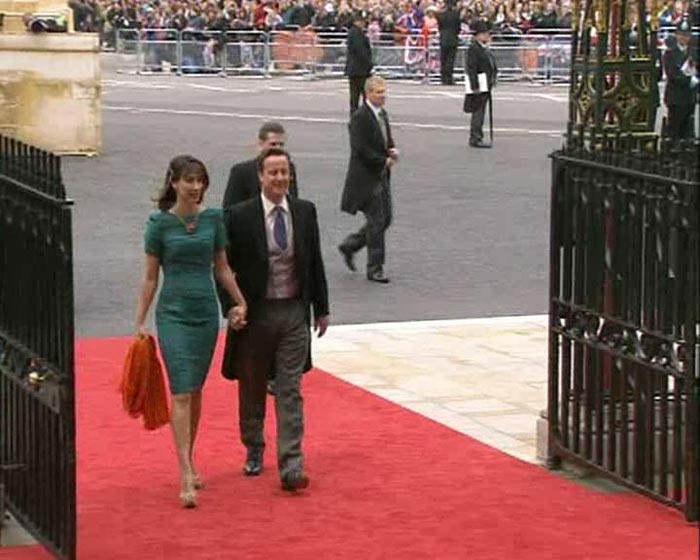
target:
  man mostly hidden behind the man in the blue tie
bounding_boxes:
[222,122,299,210]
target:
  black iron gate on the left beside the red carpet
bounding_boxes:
[0,136,76,559]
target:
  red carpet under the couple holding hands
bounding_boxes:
[0,339,698,560]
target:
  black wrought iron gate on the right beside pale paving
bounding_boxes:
[548,138,700,520]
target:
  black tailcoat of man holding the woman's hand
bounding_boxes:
[219,196,329,379]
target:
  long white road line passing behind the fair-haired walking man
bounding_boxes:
[102,105,563,137]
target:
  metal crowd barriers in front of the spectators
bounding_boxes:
[116,28,697,83]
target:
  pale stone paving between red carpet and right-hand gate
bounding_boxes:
[314,316,547,462]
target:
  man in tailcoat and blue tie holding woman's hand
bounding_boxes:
[222,148,329,491]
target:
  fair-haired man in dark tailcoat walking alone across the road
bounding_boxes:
[338,76,399,284]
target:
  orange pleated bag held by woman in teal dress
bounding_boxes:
[119,335,170,430]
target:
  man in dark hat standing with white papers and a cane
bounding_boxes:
[464,20,498,148]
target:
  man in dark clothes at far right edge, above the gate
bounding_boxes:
[664,19,698,139]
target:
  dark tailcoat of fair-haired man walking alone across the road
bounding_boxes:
[340,104,394,214]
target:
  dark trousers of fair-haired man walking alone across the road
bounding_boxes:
[342,181,392,274]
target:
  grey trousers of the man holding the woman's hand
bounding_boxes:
[237,299,310,478]
